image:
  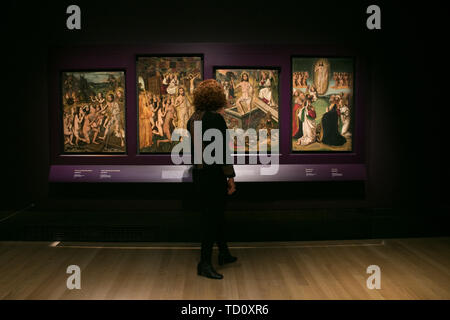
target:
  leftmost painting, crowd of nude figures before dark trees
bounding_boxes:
[62,71,126,153]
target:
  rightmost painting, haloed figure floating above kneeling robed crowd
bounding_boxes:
[292,58,354,152]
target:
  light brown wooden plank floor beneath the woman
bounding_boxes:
[0,238,450,300]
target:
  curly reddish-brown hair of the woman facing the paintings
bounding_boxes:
[194,79,227,111]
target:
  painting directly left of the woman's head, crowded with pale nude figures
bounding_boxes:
[136,56,203,153]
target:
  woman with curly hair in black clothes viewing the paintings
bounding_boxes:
[187,79,237,279]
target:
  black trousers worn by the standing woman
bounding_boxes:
[193,167,228,263]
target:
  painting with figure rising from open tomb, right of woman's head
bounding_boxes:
[215,68,279,153]
